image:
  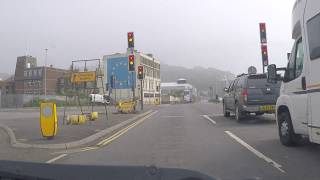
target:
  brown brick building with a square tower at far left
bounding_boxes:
[14,56,69,95]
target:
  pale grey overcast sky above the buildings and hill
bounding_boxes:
[0,0,294,73]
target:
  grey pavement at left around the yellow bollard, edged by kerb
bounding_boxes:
[0,106,152,148]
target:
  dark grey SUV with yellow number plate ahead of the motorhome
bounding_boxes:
[223,74,281,121]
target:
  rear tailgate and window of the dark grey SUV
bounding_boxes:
[247,74,281,105]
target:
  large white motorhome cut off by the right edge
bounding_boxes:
[268,0,320,146]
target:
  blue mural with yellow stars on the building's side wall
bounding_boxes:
[104,56,136,89]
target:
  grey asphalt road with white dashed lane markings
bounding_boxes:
[3,103,320,180]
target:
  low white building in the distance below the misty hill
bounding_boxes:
[161,78,197,104]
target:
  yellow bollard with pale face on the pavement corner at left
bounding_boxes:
[40,102,58,137]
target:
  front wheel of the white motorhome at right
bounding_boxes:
[278,112,301,146]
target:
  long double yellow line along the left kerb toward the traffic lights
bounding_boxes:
[97,111,157,147]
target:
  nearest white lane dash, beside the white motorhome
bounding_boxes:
[225,131,286,173]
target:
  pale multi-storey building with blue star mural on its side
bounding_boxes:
[103,52,161,104]
